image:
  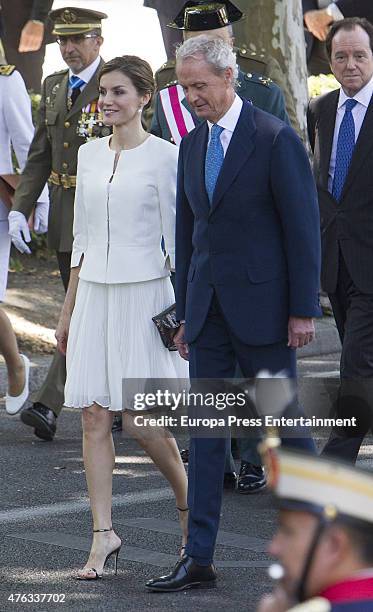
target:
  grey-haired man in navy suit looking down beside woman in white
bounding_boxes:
[147,36,320,591]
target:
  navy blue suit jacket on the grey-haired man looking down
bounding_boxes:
[176,102,320,345]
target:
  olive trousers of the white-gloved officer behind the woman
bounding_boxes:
[32,252,71,417]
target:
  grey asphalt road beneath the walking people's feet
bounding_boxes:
[0,355,373,612]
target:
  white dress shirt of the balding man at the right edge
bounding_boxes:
[328,77,373,193]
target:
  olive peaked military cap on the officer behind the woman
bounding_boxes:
[49,6,107,36]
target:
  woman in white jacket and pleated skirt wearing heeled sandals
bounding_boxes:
[56,56,188,580]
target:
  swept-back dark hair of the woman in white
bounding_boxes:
[98,55,155,108]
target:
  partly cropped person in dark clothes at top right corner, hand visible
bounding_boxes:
[302,0,373,74]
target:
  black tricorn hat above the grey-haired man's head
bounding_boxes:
[167,0,245,32]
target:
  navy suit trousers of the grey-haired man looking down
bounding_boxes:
[186,296,316,565]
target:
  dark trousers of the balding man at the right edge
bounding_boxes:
[323,254,373,462]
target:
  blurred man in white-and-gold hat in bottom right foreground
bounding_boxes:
[257,448,373,612]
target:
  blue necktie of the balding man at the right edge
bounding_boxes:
[332,99,357,202]
